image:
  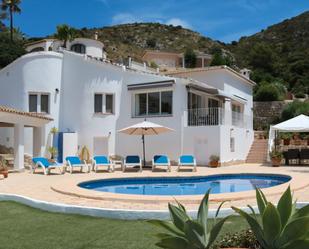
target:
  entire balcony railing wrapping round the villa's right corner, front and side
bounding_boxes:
[187,108,252,128]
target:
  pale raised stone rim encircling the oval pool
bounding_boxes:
[50,172,309,204]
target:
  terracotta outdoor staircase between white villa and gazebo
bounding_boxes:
[246,138,268,163]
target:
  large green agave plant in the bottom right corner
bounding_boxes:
[232,187,309,249]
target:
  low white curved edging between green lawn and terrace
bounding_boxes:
[0,193,309,220]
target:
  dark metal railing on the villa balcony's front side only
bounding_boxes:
[188,108,224,126]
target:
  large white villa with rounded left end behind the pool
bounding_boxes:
[0,38,255,169]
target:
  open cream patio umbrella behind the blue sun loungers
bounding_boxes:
[118,120,173,167]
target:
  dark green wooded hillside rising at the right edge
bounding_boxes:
[227,11,309,95]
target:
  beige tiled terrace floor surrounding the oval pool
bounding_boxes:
[0,164,309,210]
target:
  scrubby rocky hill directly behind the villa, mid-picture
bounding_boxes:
[72,23,221,61]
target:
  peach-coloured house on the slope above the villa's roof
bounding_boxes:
[142,50,212,70]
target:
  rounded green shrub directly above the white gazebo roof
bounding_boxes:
[281,100,309,121]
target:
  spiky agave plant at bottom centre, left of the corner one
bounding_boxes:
[149,190,229,249]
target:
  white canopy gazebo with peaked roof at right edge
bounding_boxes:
[268,114,309,159]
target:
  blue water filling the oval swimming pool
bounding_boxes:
[79,174,291,195]
